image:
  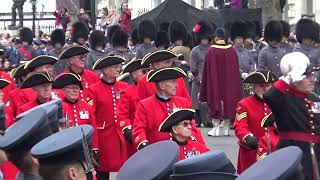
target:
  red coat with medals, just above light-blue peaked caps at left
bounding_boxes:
[62,99,98,150]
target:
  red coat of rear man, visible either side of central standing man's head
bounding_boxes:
[138,75,191,101]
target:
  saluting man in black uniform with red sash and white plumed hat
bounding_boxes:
[264,52,320,180]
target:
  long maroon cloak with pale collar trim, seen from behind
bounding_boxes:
[200,45,240,119]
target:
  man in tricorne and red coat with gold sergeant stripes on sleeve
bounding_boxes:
[234,70,277,174]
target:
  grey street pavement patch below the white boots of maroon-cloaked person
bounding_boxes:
[200,128,239,168]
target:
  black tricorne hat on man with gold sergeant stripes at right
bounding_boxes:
[243,70,278,84]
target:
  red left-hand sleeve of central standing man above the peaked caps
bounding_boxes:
[132,102,148,149]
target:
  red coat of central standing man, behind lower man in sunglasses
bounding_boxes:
[132,95,204,148]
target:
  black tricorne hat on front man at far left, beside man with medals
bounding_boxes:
[21,72,53,89]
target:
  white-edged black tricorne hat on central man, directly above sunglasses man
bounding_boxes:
[147,67,187,82]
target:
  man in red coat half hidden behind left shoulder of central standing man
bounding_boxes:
[117,59,146,158]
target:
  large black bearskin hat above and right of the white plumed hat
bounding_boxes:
[296,19,319,44]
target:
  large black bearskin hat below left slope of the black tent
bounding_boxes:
[138,20,157,42]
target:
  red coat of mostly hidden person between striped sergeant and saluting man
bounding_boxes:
[257,128,279,160]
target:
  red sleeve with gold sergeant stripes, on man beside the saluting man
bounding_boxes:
[233,104,252,143]
